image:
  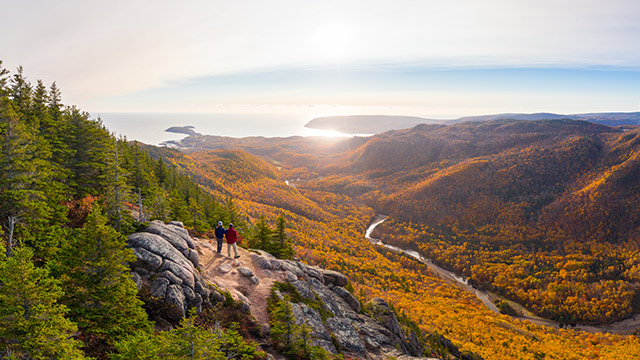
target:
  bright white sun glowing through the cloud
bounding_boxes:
[311,23,355,62]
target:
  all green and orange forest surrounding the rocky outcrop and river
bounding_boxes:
[0,63,640,359]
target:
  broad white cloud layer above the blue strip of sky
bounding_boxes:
[0,0,640,111]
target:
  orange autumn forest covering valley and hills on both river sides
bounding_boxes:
[169,120,639,359]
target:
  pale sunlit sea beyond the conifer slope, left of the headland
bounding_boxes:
[97,113,350,145]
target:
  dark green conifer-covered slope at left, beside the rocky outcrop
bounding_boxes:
[0,62,262,359]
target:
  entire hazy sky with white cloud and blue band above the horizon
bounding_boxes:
[0,0,640,118]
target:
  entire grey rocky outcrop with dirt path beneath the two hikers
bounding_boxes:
[128,225,476,360]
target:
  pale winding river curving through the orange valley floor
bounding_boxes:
[364,215,640,334]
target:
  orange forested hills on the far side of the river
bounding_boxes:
[172,119,640,324]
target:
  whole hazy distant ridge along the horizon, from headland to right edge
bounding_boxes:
[305,112,640,134]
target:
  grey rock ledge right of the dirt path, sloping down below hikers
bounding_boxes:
[251,252,438,359]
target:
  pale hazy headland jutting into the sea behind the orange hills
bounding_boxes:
[305,115,442,134]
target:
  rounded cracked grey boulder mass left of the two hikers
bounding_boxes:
[127,221,223,321]
